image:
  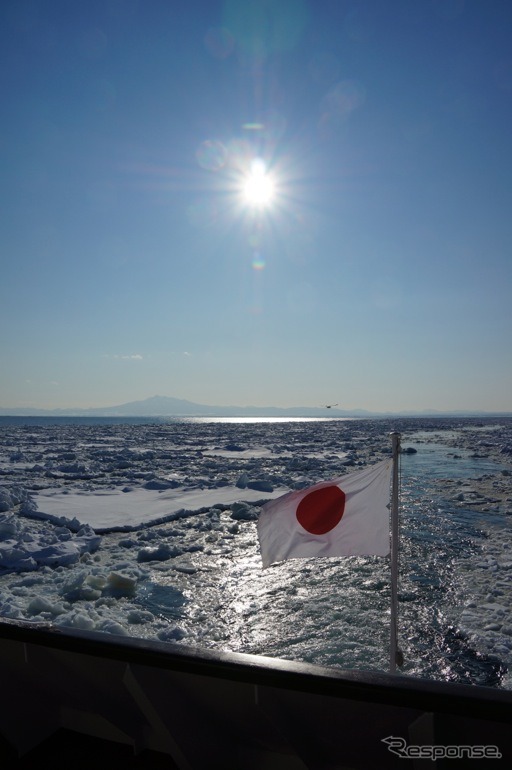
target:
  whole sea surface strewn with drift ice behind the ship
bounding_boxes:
[0,420,512,685]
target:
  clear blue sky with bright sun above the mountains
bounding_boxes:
[0,0,512,411]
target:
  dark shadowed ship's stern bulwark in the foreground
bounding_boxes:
[0,621,512,770]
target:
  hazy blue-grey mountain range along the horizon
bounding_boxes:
[0,396,510,419]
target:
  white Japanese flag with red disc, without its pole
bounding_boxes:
[258,459,393,567]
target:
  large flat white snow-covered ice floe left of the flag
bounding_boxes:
[33,487,289,532]
